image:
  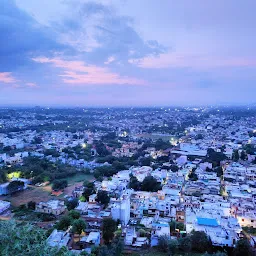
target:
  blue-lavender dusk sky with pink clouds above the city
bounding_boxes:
[0,0,256,107]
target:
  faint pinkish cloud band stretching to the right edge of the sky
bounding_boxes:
[129,53,256,69]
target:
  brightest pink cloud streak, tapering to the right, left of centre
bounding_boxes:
[33,57,146,85]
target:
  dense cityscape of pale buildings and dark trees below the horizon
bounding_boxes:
[0,106,256,255]
